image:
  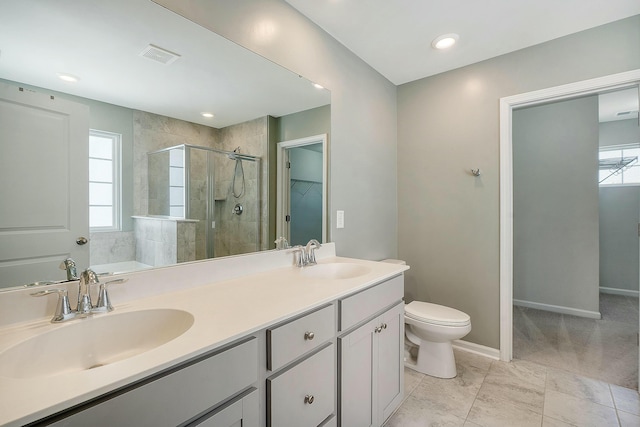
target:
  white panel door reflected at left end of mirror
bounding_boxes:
[0,83,89,284]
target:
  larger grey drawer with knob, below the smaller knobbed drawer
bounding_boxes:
[267,344,335,427]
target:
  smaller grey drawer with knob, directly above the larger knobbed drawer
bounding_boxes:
[267,305,336,371]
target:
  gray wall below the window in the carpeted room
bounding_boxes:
[600,186,640,292]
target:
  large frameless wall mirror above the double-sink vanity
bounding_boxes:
[0,0,330,289]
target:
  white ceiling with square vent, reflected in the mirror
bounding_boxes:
[0,0,330,128]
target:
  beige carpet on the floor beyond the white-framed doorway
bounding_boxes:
[513,294,638,389]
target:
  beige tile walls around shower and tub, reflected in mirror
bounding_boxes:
[91,111,269,265]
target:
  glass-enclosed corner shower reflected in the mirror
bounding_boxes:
[147,144,261,260]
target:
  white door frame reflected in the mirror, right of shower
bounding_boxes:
[276,133,329,243]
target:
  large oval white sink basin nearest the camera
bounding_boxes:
[0,309,194,378]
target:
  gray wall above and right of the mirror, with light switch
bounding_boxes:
[156,0,398,259]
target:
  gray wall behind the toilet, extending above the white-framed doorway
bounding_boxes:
[398,16,640,348]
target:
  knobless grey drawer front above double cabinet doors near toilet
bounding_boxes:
[339,275,404,331]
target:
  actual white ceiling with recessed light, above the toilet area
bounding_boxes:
[286,0,640,85]
